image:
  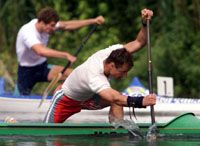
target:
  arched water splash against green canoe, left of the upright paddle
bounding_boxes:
[111,120,143,139]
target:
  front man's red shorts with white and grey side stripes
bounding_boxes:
[44,86,104,123]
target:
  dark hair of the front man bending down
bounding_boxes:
[105,48,133,68]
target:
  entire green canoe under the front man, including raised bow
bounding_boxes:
[0,113,200,137]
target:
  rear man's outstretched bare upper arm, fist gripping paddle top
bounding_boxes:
[58,16,105,30]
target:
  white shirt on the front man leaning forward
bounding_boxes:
[62,44,123,101]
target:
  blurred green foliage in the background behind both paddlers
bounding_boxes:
[0,0,200,98]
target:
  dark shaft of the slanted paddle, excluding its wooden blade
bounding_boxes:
[61,25,97,74]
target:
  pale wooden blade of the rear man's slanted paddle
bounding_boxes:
[38,73,62,108]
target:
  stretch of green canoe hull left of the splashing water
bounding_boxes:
[0,123,128,136]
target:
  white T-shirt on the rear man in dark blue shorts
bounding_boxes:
[16,19,49,67]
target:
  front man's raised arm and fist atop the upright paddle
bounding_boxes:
[124,9,153,53]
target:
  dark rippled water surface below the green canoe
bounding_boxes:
[0,136,200,146]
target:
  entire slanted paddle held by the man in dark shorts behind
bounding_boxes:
[38,25,97,108]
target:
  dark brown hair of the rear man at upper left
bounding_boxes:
[38,7,59,24]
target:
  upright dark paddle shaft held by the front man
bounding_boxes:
[147,19,155,125]
